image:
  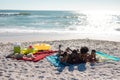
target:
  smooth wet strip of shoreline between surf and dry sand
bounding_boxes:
[0,32,120,43]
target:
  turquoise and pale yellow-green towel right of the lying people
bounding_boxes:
[96,51,120,61]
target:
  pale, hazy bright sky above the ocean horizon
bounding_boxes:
[0,0,120,10]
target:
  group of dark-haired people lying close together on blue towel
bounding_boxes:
[58,45,97,64]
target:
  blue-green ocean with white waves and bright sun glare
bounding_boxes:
[0,10,120,34]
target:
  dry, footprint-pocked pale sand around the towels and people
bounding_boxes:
[0,39,120,80]
